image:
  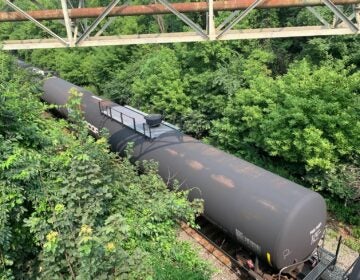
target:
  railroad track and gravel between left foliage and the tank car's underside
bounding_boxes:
[180,216,294,280]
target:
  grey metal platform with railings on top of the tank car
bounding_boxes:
[101,105,179,139]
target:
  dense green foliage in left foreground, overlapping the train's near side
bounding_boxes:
[0,53,209,279]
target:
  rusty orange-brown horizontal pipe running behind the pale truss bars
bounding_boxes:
[0,0,360,22]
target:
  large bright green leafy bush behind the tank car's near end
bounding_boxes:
[211,60,360,218]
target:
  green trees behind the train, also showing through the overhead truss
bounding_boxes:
[0,0,360,260]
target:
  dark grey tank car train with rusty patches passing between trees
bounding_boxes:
[17,59,360,279]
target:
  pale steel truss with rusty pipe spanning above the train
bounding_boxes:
[0,0,360,50]
